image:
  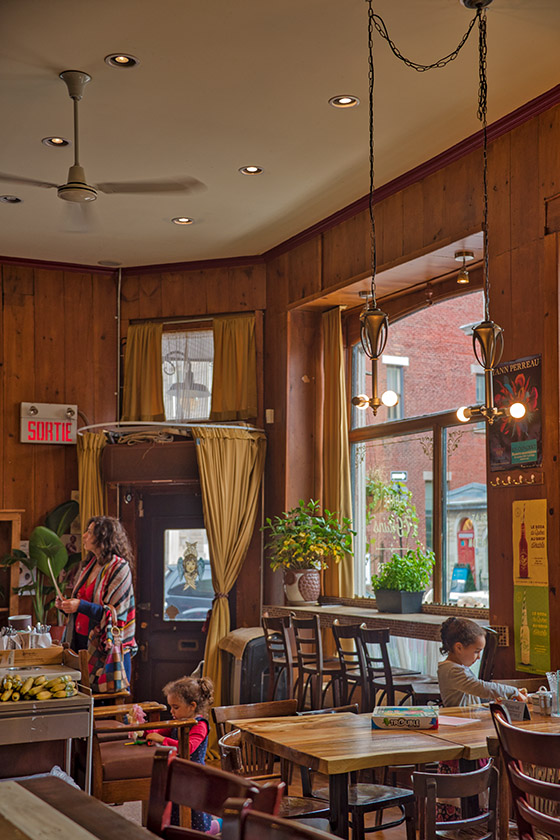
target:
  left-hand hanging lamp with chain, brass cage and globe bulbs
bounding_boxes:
[352,0,399,415]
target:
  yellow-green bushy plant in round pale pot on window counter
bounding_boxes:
[263,499,356,605]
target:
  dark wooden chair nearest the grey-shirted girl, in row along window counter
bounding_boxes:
[358,624,430,712]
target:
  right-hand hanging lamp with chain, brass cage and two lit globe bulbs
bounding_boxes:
[457,0,525,424]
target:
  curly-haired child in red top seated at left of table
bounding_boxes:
[146,677,219,834]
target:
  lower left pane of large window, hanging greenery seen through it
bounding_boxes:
[353,431,433,596]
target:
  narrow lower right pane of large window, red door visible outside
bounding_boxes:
[442,424,488,607]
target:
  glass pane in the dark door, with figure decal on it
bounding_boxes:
[163,528,214,621]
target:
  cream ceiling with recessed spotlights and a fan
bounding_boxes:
[0,0,560,266]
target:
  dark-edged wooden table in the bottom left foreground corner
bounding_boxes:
[0,776,156,840]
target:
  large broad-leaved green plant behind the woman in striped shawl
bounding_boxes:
[0,501,81,623]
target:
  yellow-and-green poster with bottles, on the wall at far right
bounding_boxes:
[512,499,550,674]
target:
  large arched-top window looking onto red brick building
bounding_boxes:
[350,291,488,606]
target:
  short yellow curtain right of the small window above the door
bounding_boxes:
[210,315,257,420]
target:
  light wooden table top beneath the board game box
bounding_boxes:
[231,706,560,775]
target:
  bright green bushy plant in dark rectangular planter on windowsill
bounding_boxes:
[371,543,435,613]
